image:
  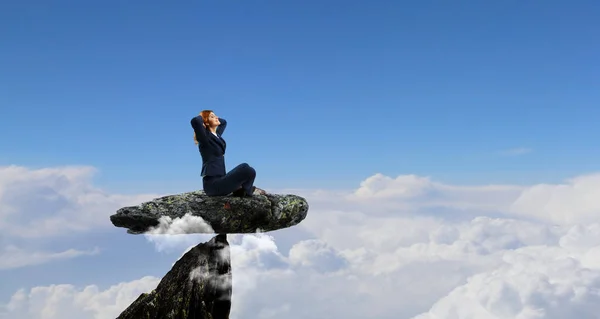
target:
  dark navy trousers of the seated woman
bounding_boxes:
[202,163,256,196]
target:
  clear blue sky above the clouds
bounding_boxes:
[0,1,600,190]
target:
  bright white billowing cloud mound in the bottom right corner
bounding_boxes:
[415,234,600,319]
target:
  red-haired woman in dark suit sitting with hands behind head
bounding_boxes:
[191,110,266,197]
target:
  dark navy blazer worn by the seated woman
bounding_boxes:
[191,115,227,177]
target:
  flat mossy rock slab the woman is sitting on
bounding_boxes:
[110,191,309,234]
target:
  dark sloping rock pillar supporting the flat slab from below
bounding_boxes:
[117,235,232,319]
